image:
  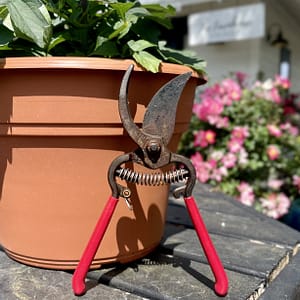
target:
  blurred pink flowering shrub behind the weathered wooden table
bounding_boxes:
[179,73,300,218]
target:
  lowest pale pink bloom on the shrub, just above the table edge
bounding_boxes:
[259,193,291,219]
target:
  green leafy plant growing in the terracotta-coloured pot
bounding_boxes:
[0,0,205,73]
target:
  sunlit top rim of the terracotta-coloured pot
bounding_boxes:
[0,56,206,82]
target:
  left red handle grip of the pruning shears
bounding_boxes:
[72,196,119,296]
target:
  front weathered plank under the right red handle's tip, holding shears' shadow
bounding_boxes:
[88,254,264,300]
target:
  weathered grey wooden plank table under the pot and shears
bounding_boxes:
[0,184,300,300]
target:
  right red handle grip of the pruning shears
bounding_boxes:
[184,196,228,296]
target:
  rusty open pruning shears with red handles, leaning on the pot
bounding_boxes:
[72,65,228,296]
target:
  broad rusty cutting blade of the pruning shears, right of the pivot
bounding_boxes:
[143,72,192,145]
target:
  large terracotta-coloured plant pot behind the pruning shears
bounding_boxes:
[0,57,204,269]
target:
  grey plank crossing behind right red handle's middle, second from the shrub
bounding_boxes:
[161,224,290,278]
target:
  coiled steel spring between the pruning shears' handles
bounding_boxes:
[116,168,189,186]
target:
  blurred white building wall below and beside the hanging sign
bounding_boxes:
[188,0,300,92]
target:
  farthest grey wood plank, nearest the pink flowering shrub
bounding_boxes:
[167,185,300,248]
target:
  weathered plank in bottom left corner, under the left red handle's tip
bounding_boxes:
[0,251,142,300]
